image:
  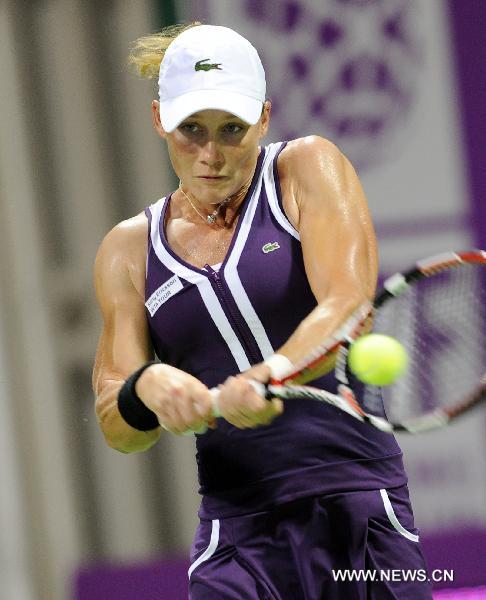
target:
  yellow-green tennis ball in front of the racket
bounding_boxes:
[348,333,408,385]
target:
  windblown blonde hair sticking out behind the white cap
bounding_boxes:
[128,21,202,79]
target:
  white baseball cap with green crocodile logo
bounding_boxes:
[159,25,266,132]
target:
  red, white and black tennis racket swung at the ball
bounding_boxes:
[205,250,486,433]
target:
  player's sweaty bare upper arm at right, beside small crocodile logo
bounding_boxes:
[279,136,378,304]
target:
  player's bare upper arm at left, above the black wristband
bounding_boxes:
[93,217,152,397]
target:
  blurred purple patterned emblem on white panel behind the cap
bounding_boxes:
[241,0,422,167]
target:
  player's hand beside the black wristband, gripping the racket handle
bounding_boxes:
[135,364,215,435]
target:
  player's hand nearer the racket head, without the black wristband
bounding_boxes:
[218,363,283,429]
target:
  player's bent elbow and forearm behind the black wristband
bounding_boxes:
[96,381,161,453]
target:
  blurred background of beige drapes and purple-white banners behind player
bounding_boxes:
[0,0,486,600]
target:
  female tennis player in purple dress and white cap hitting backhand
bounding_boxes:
[94,24,431,600]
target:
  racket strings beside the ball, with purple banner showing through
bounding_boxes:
[363,265,486,422]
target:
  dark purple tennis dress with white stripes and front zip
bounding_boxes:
[146,143,430,600]
